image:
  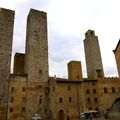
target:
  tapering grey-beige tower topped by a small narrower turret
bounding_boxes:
[84,30,104,78]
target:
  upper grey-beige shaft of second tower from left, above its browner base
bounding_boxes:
[25,9,48,82]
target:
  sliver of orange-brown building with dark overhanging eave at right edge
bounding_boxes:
[113,40,120,77]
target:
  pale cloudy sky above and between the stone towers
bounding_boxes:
[0,0,120,77]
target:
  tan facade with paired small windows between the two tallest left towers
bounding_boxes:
[7,74,27,120]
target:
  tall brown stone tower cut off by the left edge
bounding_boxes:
[0,8,15,120]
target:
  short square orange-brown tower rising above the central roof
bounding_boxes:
[68,61,83,80]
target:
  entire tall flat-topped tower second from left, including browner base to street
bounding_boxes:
[25,9,48,119]
